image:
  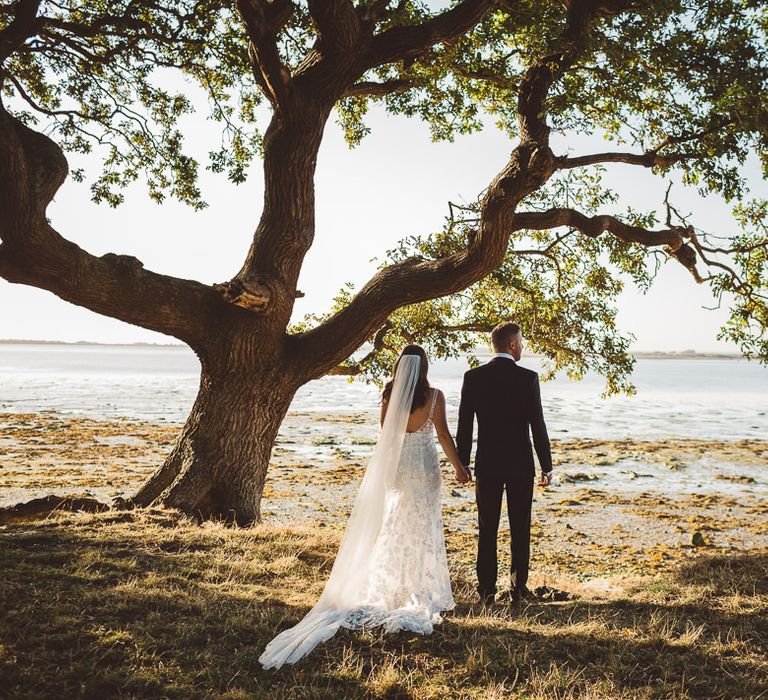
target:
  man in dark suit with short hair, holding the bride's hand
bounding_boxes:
[456,323,552,604]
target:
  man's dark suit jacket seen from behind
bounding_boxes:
[456,357,552,476]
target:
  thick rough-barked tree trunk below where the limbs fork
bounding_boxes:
[132,350,298,525]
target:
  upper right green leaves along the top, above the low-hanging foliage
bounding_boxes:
[349,0,768,200]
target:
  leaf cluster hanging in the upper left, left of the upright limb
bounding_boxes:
[0,0,261,208]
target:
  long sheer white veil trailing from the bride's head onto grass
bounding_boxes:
[259,355,421,668]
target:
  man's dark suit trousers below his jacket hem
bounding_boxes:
[475,473,534,596]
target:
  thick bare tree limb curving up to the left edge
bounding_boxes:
[0,103,222,348]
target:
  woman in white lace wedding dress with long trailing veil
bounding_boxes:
[259,345,472,668]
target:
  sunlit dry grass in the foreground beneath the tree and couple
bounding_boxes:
[0,510,768,699]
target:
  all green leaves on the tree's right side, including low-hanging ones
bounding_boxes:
[308,0,768,394]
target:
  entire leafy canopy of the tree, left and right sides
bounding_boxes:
[0,0,768,393]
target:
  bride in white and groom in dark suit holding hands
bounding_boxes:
[259,323,552,668]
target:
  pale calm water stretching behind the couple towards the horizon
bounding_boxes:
[0,344,768,439]
